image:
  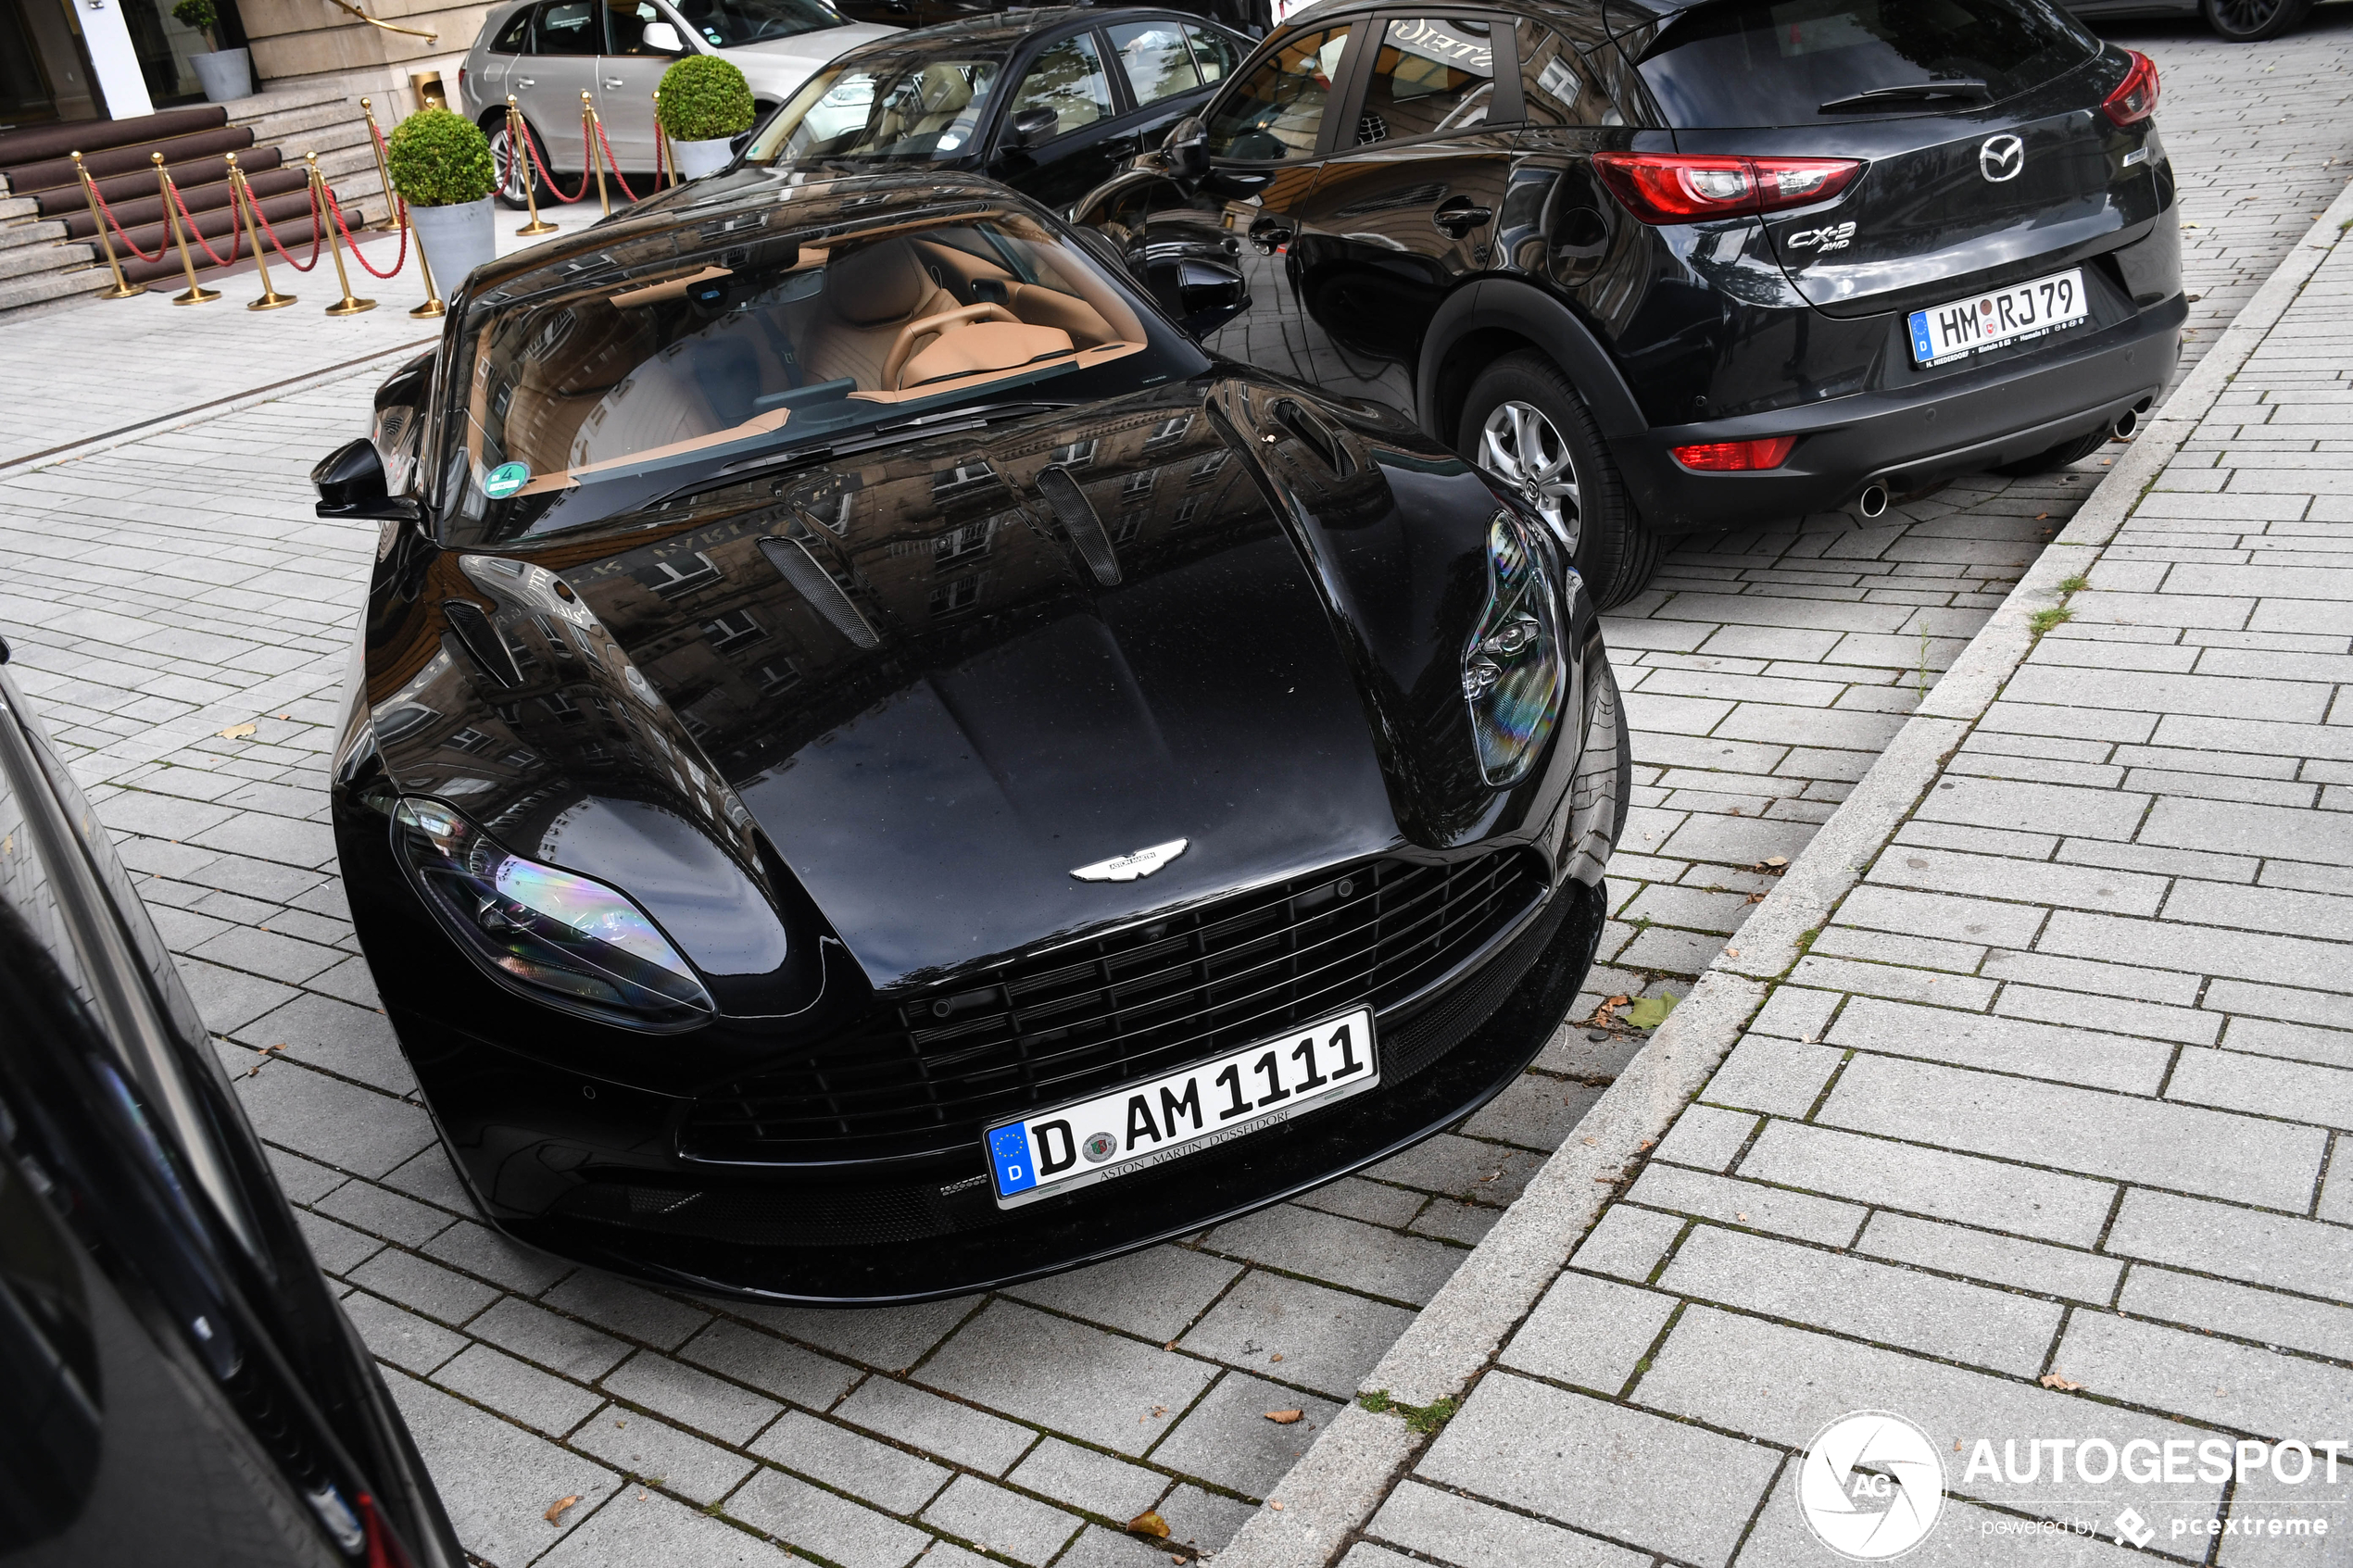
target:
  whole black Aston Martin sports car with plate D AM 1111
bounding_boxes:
[315,169,1629,1302]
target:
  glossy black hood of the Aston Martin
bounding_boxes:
[367,374,1553,987]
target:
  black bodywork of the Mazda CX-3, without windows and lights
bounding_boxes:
[1077,0,2186,533]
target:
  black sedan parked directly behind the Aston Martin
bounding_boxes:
[744,7,1250,211]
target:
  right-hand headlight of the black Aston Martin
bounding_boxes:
[1464,512,1567,790]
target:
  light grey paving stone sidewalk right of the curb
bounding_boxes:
[1327,193,2353,1568]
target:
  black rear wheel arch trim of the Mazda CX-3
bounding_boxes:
[1415,278,1650,446]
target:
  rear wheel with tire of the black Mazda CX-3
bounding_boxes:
[1454,350,1664,608]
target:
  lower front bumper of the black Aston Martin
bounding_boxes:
[371,879,1604,1307]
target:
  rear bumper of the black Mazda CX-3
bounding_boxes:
[1612,294,2188,533]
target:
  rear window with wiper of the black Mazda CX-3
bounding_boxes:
[1635,0,2099,130]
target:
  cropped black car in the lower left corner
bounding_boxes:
[0,644,466,1568]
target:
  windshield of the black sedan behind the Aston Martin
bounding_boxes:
[749,49,1002,162]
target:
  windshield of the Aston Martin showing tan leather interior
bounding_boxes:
[440,194,1207,546]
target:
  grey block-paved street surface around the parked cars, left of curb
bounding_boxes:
[0,23,2353,1568]
